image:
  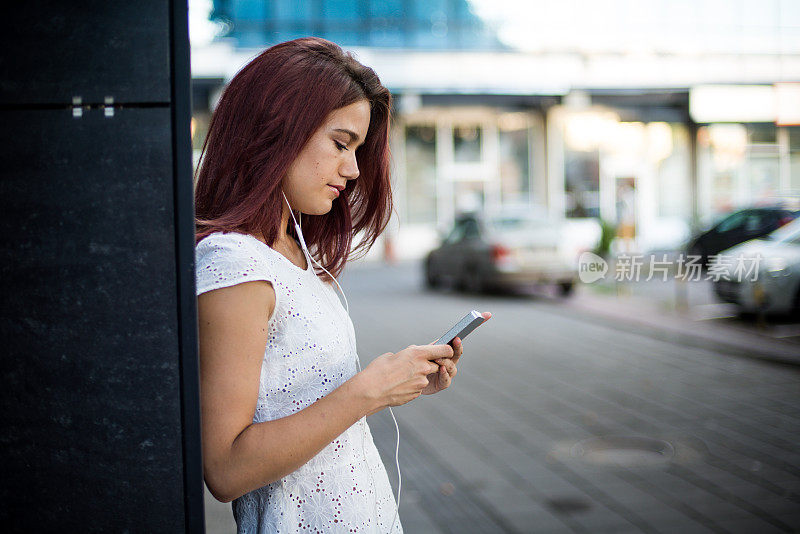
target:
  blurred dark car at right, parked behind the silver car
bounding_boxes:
[687,204,800,265]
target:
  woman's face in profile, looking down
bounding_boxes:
[282,100,370,215]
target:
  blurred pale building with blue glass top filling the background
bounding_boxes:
[192,0,800,257]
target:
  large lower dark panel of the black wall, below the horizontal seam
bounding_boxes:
[0,108,183,532]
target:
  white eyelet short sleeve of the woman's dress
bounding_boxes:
[195,233,274,295]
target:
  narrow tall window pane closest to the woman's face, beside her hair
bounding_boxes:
[406,125,436,223]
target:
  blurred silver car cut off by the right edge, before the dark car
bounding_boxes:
[711,219,800,313]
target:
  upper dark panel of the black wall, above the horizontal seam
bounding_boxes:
[0,0,170,104]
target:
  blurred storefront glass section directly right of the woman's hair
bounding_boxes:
[400,112,546,229]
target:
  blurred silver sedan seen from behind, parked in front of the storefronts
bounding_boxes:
[424,211,577,296]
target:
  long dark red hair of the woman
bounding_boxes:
[195,37,392,276]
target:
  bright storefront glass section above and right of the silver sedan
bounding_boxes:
[548,105,693,251]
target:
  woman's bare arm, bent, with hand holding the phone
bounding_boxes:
[198,281,453,502]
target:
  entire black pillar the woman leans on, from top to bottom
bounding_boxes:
[0,0,204,532]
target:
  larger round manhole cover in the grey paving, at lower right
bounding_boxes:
[570,436,675,466]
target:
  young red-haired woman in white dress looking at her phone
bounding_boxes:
[196,38,489,533]
